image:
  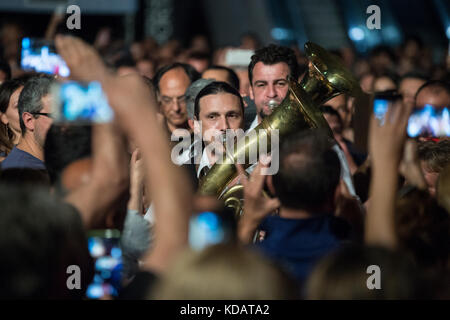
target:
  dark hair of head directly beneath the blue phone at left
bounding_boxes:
[44,124,92,185]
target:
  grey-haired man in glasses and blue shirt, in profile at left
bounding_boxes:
[1,76,54,170]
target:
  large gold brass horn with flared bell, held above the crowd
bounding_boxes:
[198,42,361,215]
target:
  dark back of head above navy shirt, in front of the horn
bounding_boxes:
[273,129,341,210]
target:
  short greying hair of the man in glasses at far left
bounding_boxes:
[18,75,55,135]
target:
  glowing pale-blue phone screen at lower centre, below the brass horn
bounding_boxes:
[189,211,234,250]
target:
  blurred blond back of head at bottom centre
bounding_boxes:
[152,244,298,300]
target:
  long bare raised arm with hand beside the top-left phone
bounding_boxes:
[56,36,192,271]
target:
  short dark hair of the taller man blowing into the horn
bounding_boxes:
[248,44,300,85]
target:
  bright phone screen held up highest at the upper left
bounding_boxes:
[20,38,70,77]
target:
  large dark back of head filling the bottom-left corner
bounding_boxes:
[0,186,93,299]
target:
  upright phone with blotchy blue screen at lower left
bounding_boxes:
[86,229,122,299]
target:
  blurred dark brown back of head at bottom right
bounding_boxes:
[307,246,426,300]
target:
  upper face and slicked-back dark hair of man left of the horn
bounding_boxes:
[189,81,244,142]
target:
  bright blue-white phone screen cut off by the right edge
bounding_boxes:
[407,104,450,138]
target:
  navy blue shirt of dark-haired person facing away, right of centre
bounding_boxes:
[256,215,350,284]
